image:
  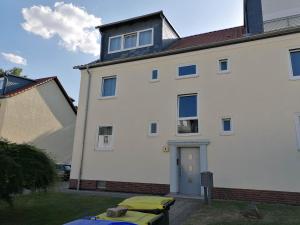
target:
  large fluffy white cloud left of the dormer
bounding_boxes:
[22,2,101,56]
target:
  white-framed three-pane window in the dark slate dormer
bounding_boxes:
[108,28,153,53]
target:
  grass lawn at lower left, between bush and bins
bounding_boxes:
[0,192,122,225]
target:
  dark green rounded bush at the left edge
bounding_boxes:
[0,140,56,205]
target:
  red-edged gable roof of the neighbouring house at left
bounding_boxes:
[4,76,77,113]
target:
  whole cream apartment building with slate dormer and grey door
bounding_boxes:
[70,1,300,203]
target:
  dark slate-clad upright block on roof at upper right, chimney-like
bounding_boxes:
[244,0,264,35]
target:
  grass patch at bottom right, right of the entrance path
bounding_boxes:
[185,201,300,225]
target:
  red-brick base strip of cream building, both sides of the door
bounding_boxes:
[69,179,300,205]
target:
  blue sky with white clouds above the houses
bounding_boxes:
[0,0,243,103]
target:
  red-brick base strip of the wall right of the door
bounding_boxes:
[213,188,300,205]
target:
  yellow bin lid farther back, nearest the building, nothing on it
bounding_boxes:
[119,196,175,210]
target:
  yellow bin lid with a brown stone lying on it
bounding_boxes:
[96,211,162,225]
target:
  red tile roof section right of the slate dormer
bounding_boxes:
[168,26,245,50]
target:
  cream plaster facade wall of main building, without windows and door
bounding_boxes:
[71,31,300,192]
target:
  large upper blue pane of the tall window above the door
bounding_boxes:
[179,95,197,118]
